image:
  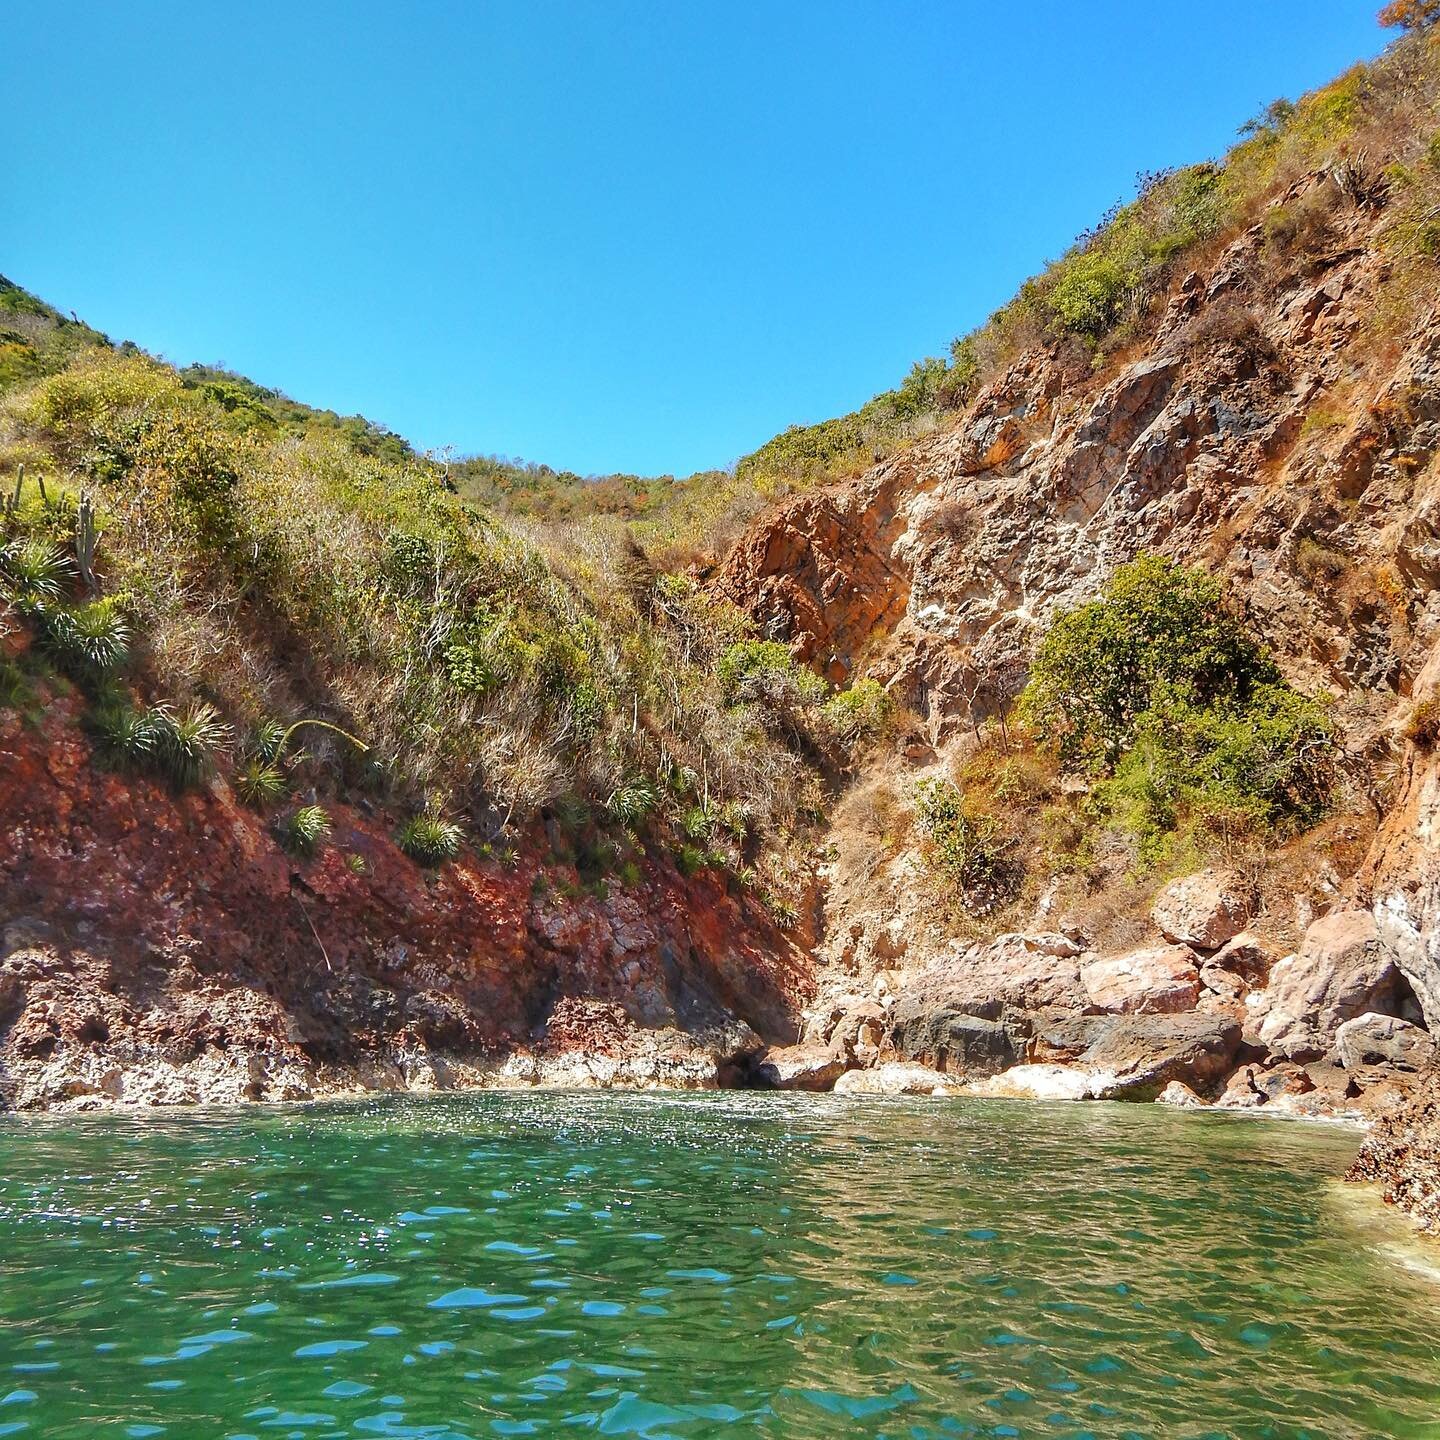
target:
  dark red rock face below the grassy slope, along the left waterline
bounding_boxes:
[0,700,811,1103]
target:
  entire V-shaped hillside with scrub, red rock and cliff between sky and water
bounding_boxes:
[8,23,1440,1218]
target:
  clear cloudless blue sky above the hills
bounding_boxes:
[0,0,1385,474]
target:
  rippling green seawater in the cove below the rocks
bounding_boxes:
[0,1093,1440,1440]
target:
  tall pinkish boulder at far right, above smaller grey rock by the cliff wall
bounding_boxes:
[1256,910,1398,1060]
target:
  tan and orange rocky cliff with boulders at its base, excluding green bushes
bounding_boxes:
[713,170,1440,1221]
